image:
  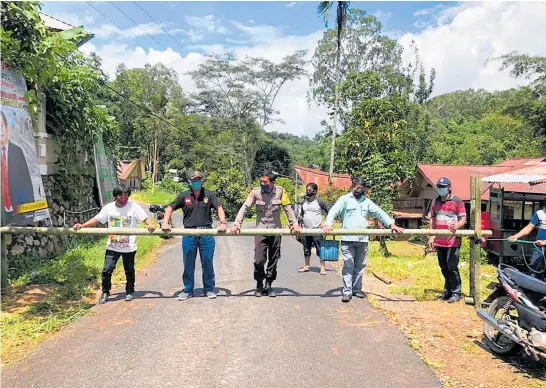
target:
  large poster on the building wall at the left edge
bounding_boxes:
[0,62,49,226]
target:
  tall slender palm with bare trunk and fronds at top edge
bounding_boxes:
[317,1,350,184]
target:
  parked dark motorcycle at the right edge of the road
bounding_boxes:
[478,242,546,361]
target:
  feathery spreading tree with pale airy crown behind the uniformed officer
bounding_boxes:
[189,51,306,185]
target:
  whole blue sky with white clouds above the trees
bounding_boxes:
[42,1,546,137]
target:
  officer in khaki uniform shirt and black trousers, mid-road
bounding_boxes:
[227,172,301,297]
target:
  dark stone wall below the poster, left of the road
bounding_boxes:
[8,175,99,262]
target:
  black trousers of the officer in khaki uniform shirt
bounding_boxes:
[254,236,281,283]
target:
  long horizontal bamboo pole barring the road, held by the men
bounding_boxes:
[0,226,493,237]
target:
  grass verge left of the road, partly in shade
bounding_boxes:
[1,237,163,364]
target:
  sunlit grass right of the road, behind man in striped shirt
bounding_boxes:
[369,241,496,301]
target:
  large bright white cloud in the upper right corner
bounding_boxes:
[400,2,546,95]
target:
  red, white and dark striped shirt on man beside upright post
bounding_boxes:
[428,195,466,248]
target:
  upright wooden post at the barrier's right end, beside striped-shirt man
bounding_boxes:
[470,176,482,308]
